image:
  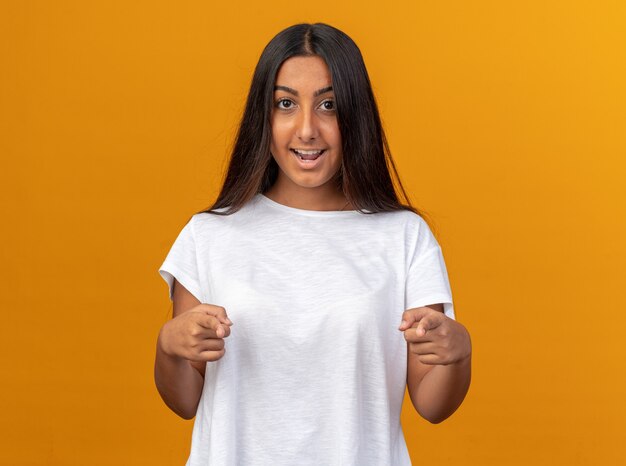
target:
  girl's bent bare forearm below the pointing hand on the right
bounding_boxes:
[410,356,471,424]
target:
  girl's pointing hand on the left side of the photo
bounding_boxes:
[159,304,232,362]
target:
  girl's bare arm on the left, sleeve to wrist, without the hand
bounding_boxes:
[154,280,211,419]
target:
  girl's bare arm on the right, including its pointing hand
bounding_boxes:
[401,304,471,424]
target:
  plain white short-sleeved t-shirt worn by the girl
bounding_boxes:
[159,194,454,466]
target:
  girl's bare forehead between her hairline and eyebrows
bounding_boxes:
[276,55,332,90]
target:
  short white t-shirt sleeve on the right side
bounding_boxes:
[405,217,455,319]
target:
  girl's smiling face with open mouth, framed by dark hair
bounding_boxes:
[270,56,342,198]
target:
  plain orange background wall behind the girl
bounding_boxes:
[0,0,626,466]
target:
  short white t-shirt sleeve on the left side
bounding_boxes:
[159,217,202,302]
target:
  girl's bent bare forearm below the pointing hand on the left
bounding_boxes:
[154,334,204,419]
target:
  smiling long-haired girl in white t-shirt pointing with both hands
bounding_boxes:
[155,23,471,466]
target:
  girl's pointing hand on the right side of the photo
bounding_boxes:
[398,307,472,365]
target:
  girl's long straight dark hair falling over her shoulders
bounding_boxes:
[197,23,432,223]
